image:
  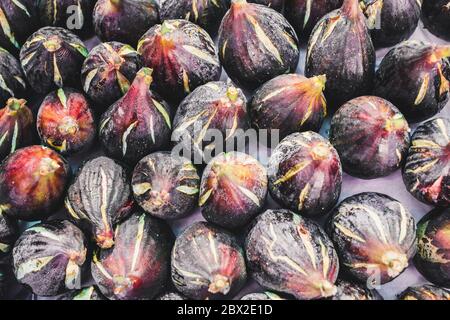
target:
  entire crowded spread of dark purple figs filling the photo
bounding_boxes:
[0,0,450,300]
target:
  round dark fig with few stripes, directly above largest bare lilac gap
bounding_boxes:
[330,96,410,179]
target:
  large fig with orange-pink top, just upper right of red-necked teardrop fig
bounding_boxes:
[138,20,222,104]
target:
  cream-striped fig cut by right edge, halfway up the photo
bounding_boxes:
[403,118,450,207]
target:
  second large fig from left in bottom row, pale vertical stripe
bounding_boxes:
[91,213,173,300]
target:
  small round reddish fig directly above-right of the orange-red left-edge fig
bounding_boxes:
[36,88,97,155]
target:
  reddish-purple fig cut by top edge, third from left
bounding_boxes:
[93,0,159,47]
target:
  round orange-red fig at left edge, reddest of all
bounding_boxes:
[0,146,70,221]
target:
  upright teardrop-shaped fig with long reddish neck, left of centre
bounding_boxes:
[99,68,172,164]
